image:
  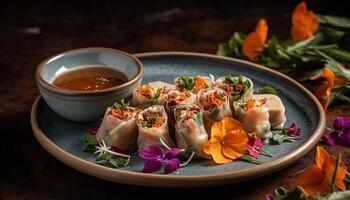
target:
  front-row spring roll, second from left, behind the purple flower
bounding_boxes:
[137,105,175,151]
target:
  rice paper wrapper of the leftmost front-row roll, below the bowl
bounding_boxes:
[96,107,138,151]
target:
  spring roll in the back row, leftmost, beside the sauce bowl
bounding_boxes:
[131,81,175,108]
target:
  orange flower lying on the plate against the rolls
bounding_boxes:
[203,117,248,164]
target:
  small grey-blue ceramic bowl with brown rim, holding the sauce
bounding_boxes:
[35,47,143,122]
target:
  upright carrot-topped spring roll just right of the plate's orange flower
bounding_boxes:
[236,98,272,139]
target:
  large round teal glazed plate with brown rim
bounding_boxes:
[31,52,325,188]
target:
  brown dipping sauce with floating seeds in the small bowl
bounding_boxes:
[52,66,128,91]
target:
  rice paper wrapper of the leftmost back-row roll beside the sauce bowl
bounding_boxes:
[131,81,175,108]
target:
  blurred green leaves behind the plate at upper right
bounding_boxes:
[217,15,350,108]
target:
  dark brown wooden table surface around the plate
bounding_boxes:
[0,0,350,199]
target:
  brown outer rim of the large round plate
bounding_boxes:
[30,51,326,188]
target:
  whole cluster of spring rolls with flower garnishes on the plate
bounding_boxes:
[84,75,300,173]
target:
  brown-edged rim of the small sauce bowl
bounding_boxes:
[35,47,144,96]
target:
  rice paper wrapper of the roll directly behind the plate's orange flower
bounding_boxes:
[198,88,232,135]
